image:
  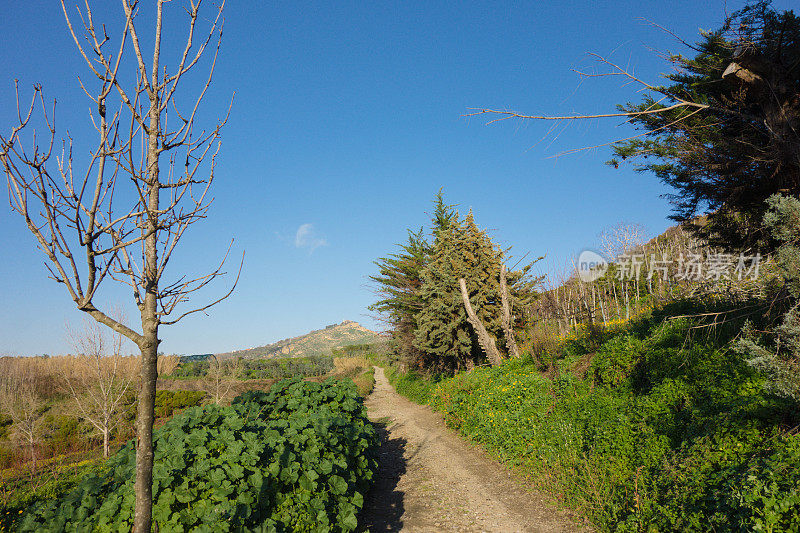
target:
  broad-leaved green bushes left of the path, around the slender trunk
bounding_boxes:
[20,380,378,531]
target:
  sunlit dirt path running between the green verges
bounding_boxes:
[359,367,581,533]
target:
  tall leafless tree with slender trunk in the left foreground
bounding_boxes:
[0,0,241,533]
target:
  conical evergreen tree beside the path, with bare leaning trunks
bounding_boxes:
[370,191,541,372]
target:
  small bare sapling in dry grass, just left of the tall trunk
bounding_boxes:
[64,320,139,457]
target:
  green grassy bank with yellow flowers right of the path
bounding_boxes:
[388,302,800,531]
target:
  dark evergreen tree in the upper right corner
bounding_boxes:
[610,1,800,251]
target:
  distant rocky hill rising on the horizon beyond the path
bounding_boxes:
[216,320,383,359]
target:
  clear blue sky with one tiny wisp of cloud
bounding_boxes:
[0,0,790,355]
